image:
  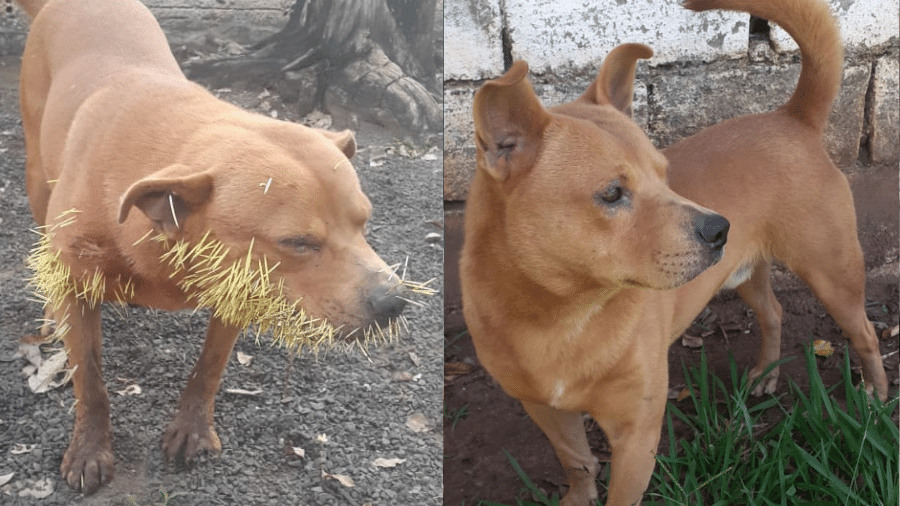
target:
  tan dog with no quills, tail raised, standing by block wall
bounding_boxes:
[460,0,887,506]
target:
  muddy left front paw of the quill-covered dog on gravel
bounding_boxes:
[59,430,115,495]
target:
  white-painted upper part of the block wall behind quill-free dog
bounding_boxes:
[444,0,898,80]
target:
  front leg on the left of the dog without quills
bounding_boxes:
[522,401,600,506]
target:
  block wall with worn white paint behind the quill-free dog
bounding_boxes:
[444,0,900,201]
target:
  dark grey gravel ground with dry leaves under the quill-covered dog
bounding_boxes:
[0,58,443,506]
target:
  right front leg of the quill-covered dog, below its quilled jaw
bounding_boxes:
[163,317,241,464]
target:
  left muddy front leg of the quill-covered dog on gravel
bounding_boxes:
[53,294,115,495]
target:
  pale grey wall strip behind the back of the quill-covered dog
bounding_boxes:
[0,0,294,55]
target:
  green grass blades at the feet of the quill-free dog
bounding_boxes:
[482,347,900,506]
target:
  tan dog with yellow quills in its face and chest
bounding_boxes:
[19,0,404,494]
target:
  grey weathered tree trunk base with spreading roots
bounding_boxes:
[186,0,442,137]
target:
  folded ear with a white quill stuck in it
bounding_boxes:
[119,164,213,238]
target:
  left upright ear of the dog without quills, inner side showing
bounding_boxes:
[472,60,550,181]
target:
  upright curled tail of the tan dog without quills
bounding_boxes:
[684,0,844,132]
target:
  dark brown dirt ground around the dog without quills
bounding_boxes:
[444,162,900,506]
